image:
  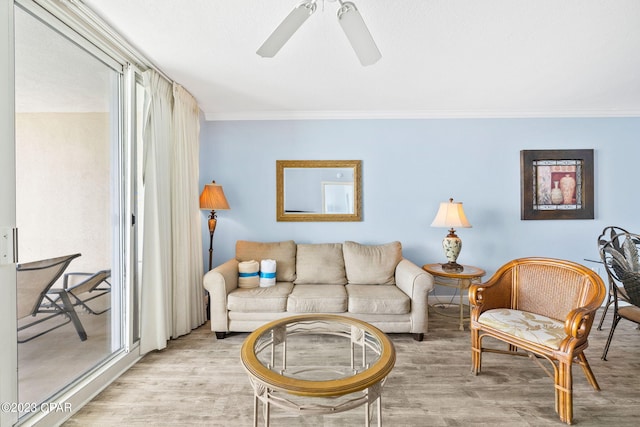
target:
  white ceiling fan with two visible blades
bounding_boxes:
[256,0,382,66]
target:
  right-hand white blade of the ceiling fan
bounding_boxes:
[338,1,382,66]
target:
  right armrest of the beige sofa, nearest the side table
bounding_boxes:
[395,258,434,334]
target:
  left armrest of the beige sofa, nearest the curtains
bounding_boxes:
[203,259,238,332]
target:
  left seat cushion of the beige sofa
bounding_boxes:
[227,282,293,313]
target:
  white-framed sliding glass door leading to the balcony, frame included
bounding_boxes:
[0,0,144,425]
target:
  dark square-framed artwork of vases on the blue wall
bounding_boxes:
[520,150,593,219]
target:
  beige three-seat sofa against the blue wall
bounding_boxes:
[204,240,434,341]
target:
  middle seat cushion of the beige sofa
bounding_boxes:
[287,285,347,313]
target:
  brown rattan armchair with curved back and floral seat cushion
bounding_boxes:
[469,258,607,424]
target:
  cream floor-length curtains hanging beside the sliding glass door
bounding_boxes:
[140,70,205,354]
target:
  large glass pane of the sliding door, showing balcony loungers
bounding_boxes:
[15,8,123,414]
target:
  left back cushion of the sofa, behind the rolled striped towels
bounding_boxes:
[236,240,296,282]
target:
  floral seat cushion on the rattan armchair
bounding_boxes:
[478,308,567,350]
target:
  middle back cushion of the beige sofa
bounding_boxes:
[294,243,347,285]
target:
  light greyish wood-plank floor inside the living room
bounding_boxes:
[65,315,640,427]
